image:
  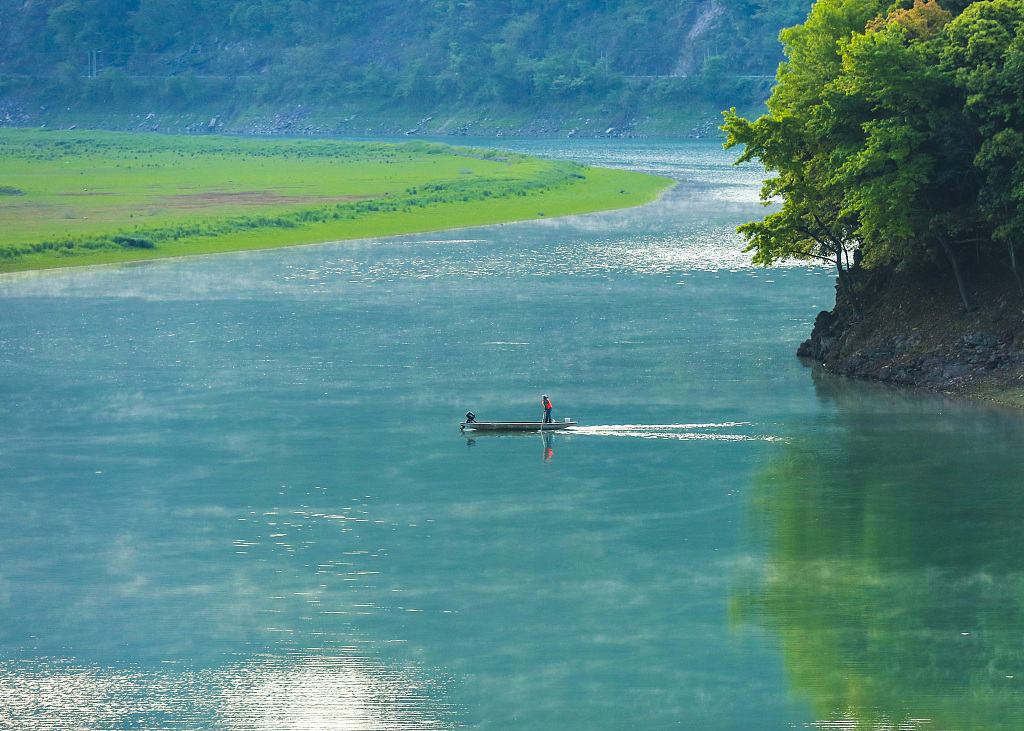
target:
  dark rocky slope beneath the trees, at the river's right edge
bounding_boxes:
[797,270,1024,406]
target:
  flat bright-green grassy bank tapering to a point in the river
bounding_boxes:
[0,129,672,271]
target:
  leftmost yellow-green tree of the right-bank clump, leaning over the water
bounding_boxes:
[722,0,880,311]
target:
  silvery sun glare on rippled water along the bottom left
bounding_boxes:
[0,655,458,731]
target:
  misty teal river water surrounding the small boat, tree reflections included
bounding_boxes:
[0,140,1024,731]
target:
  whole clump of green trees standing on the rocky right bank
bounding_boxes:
[723,0,1024,308]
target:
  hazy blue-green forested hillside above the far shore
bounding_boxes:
[0,0,810,134]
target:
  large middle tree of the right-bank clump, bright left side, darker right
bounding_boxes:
[836,0,985,309]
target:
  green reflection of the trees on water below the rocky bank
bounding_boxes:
[733,373,1024,731]
